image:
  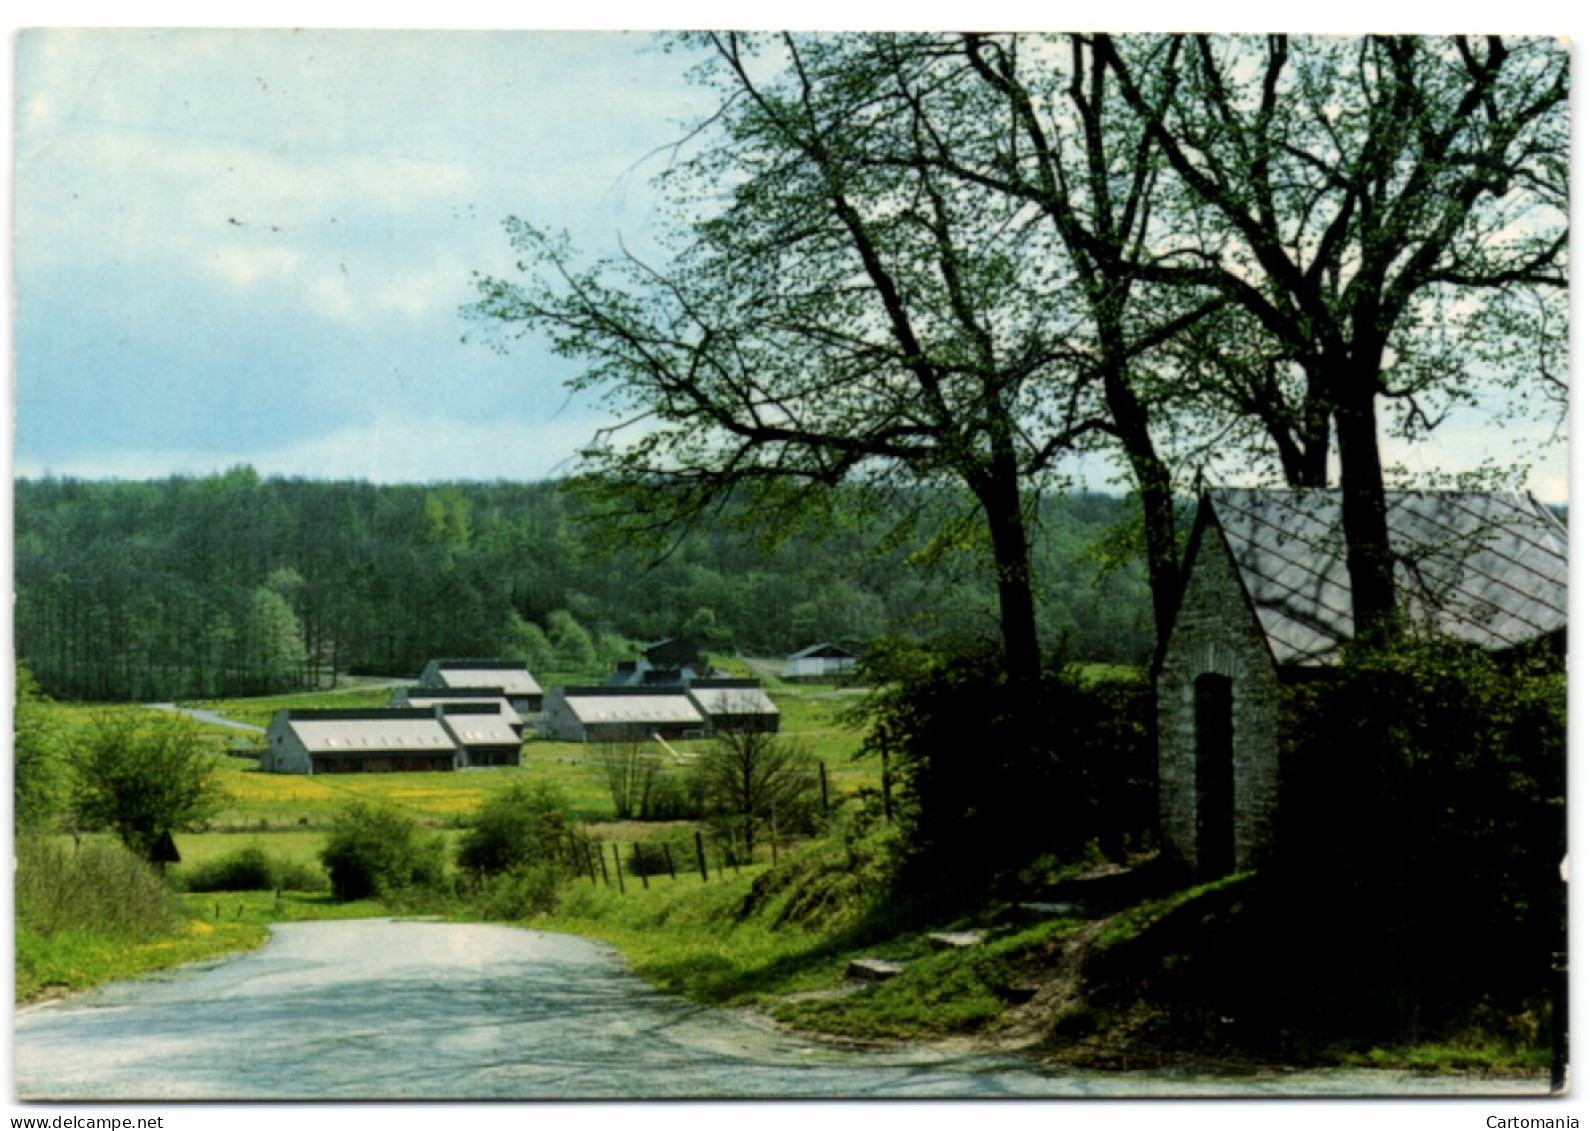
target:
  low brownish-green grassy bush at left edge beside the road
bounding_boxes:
[16,837,181,940]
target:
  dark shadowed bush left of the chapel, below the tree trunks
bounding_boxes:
[859,647,1156,900]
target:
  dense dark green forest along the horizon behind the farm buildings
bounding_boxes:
[14,468,1153,700]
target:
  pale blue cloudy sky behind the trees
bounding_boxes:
[13,19,1568,499]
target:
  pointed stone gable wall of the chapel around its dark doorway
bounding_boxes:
[1156,511,1280,876]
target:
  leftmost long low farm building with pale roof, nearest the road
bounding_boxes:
[259,708,461,775]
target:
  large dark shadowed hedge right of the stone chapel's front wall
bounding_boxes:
[1282,633,1568,1036]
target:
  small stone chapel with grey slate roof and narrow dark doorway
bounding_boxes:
[1154,488,1568,876]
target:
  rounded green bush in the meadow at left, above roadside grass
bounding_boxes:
[67,713,224,859]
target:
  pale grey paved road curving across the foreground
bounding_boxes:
[14,921,1545,1101]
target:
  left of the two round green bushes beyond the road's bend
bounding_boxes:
[320,805,447,902]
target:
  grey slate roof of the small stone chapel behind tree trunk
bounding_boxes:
[1205,488,1568,665]
